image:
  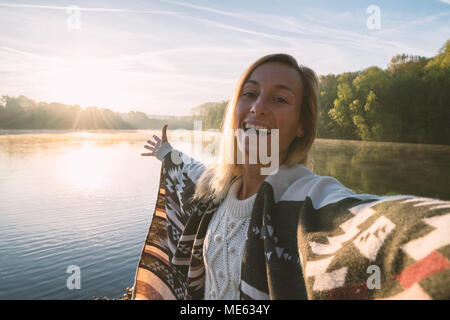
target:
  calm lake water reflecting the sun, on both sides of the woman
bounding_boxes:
[0,130,450,299]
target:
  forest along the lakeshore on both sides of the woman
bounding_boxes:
[0,39,450,145]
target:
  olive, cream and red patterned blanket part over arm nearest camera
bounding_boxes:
[301,196,450,299]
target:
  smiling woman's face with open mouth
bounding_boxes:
[235,62,303,163]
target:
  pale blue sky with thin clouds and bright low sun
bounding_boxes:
[0,0,450,115]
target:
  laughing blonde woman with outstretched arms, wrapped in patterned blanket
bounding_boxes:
[139,54,450,299]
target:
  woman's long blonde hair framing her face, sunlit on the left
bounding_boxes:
[193,54,319,201]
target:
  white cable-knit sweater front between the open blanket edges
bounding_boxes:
[203,179,256,300]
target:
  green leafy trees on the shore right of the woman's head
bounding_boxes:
[318,40,450,144]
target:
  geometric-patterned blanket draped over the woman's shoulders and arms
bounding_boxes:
[133,151,450,300]
